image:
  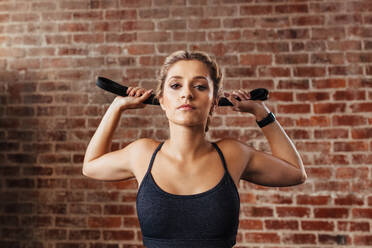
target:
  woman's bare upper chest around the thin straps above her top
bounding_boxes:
[135,143,242,195]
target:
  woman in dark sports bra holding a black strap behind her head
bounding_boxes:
[83,51,307,248]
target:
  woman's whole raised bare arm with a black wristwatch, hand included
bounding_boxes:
[225,91,307,187]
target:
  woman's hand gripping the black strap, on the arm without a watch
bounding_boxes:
[113,87,153,110]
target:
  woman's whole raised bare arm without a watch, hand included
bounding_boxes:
[82,87,151,181]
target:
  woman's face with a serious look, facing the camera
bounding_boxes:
[159,60,213,130]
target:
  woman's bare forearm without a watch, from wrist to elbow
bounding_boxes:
[84,103,122,164]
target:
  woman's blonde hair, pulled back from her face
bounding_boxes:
[155,50,223,132]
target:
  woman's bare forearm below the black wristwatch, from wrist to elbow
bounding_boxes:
[256,107,306,175]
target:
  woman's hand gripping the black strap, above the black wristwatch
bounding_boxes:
[224,90,270,115]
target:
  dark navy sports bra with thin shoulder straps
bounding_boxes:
[136,142,240,248]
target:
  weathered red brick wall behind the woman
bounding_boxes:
[0,0,372,248]
